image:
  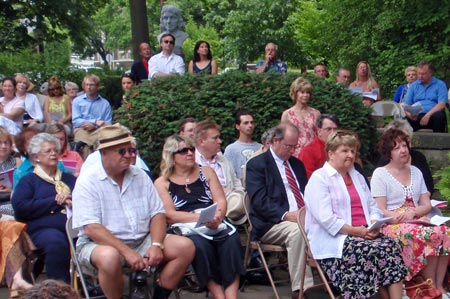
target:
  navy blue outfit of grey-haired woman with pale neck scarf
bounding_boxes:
[11,172,76,283]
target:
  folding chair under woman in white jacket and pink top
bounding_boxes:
[297,207,336,299]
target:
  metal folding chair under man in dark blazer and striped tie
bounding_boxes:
[241,195,289,299]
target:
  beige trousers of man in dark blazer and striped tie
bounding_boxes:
[261,221,314,291]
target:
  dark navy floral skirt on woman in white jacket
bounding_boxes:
[318,234,406,299]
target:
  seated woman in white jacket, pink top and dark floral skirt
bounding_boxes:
[305,130,406,299]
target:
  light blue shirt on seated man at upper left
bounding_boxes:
[72,94,112,128]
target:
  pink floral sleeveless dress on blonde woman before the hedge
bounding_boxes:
[287,107,320,158]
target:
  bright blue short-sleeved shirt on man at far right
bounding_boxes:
[405,77,448,113]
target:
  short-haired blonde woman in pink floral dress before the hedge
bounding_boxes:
[281,77,320,157]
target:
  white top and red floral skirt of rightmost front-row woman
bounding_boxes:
[371,166,450,281]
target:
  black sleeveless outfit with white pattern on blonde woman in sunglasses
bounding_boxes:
[169,166,245,289]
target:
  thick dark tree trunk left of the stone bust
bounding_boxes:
[130,0,149,60]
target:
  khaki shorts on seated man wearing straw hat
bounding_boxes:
[75,234,152,275]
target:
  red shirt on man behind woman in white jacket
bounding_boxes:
[298,136,327,179]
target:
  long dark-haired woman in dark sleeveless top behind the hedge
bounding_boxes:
[188,40,217,75]
